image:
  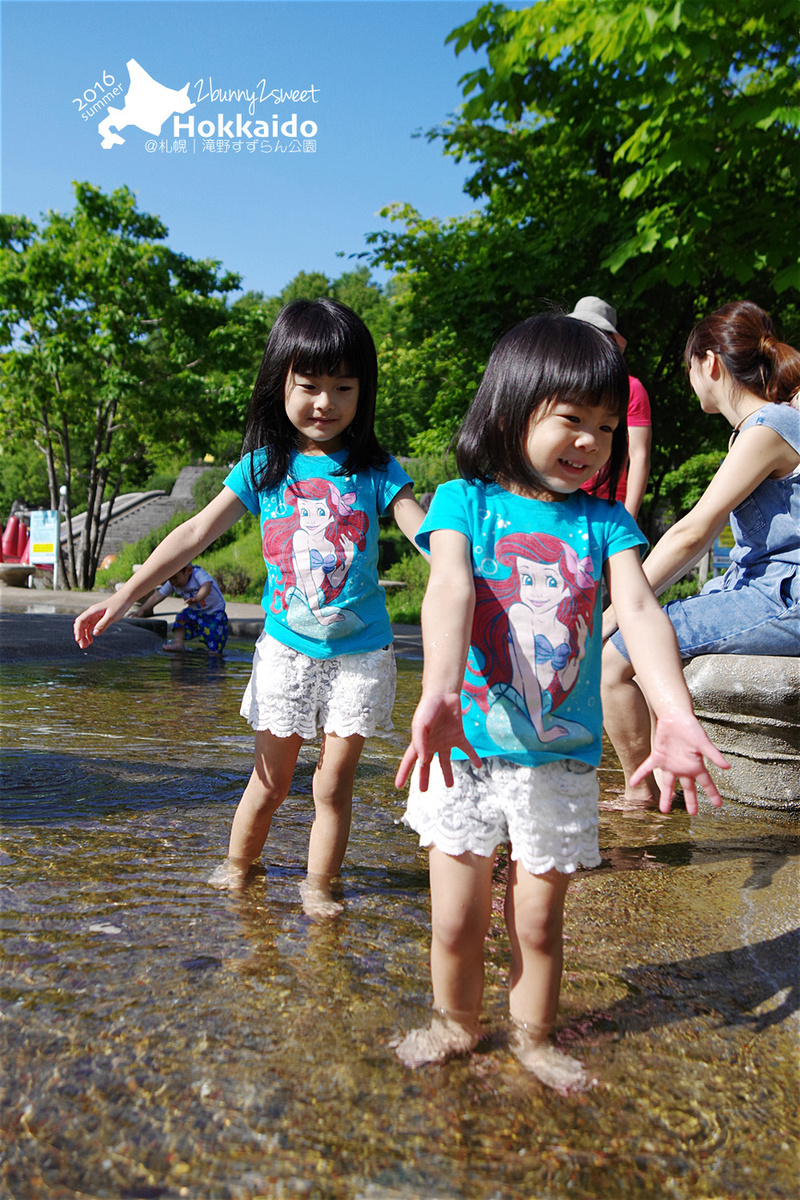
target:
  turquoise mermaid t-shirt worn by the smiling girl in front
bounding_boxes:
[416,480,645,767]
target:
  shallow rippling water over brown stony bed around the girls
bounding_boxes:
[0,642,800,1200]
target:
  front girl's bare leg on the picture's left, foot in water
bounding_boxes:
[397,847,494,1067]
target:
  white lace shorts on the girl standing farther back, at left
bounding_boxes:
[240,631,397,739]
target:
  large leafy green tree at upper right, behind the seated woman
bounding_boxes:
[371,0,800,511]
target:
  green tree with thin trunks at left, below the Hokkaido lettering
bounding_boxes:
[0,184,239,588]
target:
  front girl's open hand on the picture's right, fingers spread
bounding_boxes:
[631,713,730,816]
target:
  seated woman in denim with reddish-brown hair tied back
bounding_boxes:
[602,300,800,808]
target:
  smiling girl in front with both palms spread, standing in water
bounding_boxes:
[396,314,726,1093]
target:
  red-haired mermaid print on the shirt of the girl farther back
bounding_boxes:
[261,479,369,612]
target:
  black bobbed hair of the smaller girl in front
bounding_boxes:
[456,313,630,499]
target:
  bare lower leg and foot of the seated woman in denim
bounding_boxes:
[601,642,658,809]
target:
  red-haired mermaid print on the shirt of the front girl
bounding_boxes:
[464,533,597,745]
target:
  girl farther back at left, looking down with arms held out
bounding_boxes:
[74,299,423,917]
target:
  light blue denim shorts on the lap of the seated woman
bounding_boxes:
[612,578,800,662]
